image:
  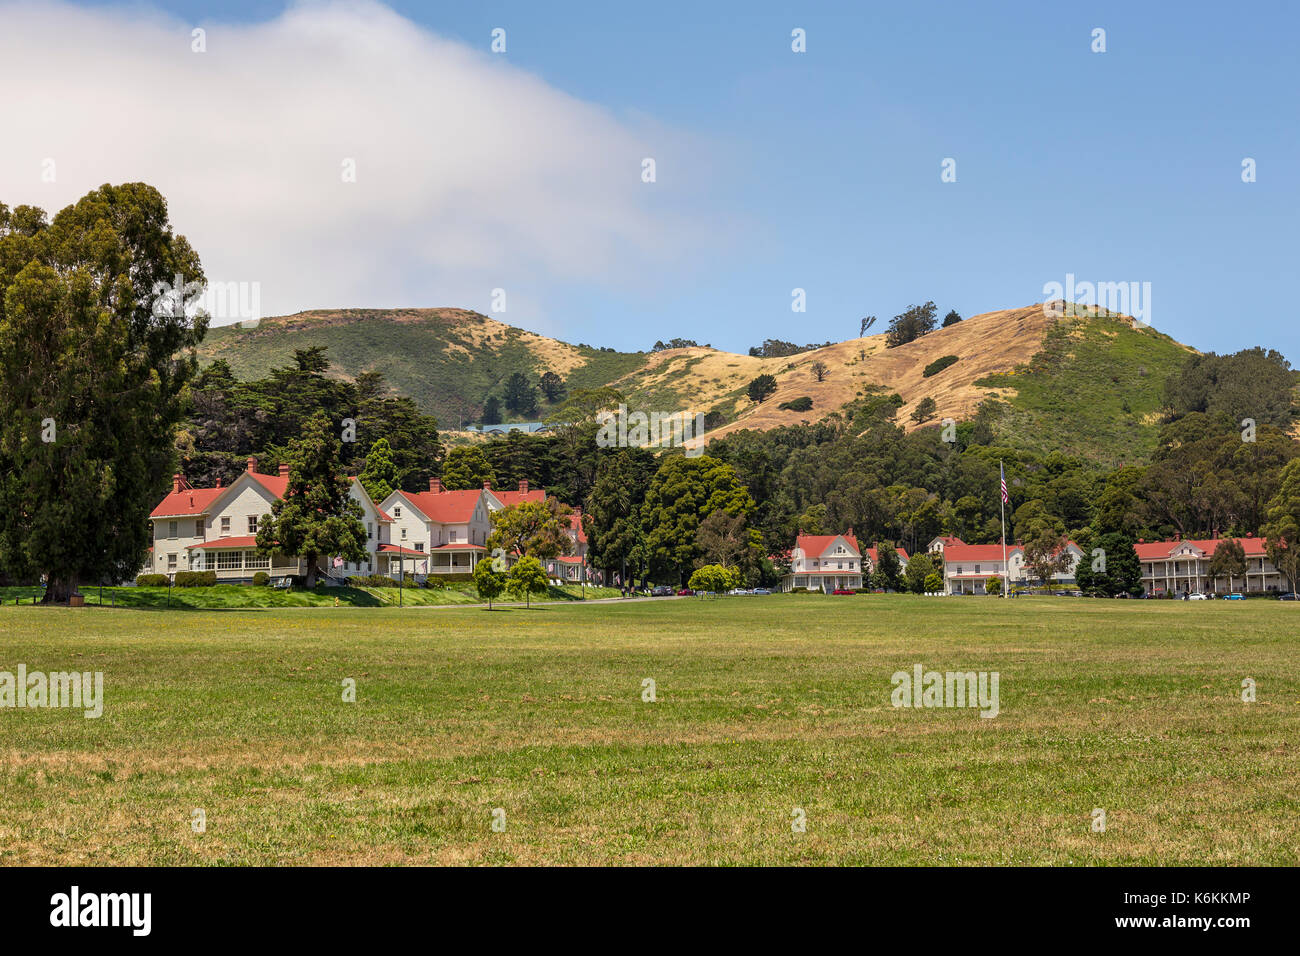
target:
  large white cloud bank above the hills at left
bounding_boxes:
[0,3,718,325]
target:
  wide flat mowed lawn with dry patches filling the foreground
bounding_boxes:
[0,594,1300,865]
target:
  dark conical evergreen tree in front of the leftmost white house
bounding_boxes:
[257,412,365,588]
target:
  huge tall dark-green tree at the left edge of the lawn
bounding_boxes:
[0,183,207,604]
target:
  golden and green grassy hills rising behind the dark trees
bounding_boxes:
[200,304,1191,463]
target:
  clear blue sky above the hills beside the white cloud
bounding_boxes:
[25,1,1300,362]
